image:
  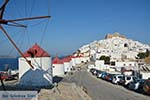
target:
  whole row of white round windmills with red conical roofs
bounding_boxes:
[19,44,90,86]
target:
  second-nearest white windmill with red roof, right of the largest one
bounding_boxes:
[52,56,65,76]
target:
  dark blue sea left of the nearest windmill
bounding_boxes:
[0,58,18,71]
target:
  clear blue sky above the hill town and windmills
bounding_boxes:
[0,0,150,55]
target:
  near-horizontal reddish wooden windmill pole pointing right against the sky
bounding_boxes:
[5,16,51,22]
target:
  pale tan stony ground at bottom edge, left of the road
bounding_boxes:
[38,82,92,100]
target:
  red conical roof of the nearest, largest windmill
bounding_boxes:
[23,43,50,57]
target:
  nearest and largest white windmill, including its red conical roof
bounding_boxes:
[19,44,53,87]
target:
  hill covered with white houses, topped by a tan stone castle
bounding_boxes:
[76,32,150,61]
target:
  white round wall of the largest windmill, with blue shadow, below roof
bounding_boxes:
[19,57,53,86]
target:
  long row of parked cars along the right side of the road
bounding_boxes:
[88,68,150,95]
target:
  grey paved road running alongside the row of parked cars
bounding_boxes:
[63,70,150,100]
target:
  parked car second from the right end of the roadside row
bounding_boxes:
[128,79,145,91]
